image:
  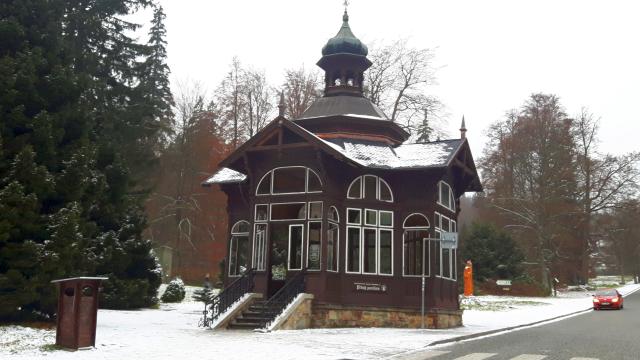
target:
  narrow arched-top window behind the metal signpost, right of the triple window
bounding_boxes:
[402,213,430,276]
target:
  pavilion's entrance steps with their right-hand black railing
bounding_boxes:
[222,270,306,330]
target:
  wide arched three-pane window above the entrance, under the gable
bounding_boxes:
[256,166,322,195]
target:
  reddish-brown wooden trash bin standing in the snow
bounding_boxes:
[52,277,107,349]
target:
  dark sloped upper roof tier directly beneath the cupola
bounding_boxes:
[296,95,389,121]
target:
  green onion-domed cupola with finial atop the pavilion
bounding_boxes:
[317,8,371,97]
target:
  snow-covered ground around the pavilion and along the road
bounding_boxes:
[0,285,640,360]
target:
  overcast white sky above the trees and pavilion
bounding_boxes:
[138,0,640,158]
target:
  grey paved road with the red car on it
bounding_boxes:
[423,291,640,360]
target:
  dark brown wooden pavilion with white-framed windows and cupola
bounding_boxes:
[204,10,482,327]
